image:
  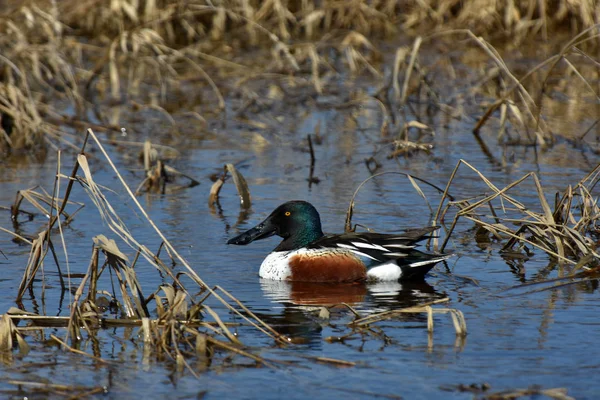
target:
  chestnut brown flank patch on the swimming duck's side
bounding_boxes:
[288,253,367,282]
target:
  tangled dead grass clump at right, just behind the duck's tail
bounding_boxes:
[435,160,600,274]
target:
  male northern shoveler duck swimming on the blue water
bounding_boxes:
[227,200,451,282]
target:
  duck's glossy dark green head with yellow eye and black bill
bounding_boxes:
[227,200,323,251]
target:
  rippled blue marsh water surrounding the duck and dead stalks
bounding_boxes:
[0,41,600,399]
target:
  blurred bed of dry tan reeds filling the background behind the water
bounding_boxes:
[0,0,600,161]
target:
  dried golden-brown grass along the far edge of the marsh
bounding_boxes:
[0,0,599,155]
